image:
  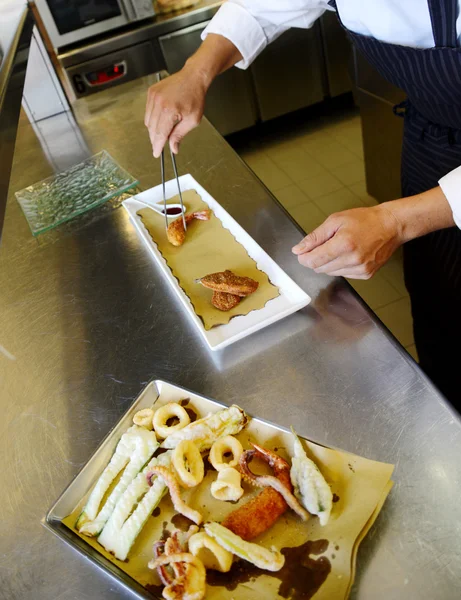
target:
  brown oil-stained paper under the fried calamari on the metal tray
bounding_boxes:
[63,394,393,600]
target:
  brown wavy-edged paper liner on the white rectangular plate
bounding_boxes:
[137,190,279,330]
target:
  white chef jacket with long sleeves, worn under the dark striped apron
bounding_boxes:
[202,0,461,228]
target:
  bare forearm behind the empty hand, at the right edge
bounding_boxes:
[381,186,455,243]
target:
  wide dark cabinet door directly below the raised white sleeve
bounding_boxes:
[251,25,326,121]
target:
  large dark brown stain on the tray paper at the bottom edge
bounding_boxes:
[207,540,331,600]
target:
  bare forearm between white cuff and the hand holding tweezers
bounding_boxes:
[184,33,242,88]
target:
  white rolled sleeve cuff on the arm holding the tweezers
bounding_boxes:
[201,2,267,69]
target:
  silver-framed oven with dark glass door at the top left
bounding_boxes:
[35,0,154,48]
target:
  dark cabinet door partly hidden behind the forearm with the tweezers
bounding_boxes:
[159,22,257,135]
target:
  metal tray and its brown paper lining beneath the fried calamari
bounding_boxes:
[43,380,393,600]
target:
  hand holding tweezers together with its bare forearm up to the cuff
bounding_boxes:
[144,33,242,158]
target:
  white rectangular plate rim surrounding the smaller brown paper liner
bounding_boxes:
[123,175,311,350]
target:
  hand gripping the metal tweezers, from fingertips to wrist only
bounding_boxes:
[144,66,208,158]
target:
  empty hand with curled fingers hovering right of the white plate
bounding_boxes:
[293,204,404,279]
